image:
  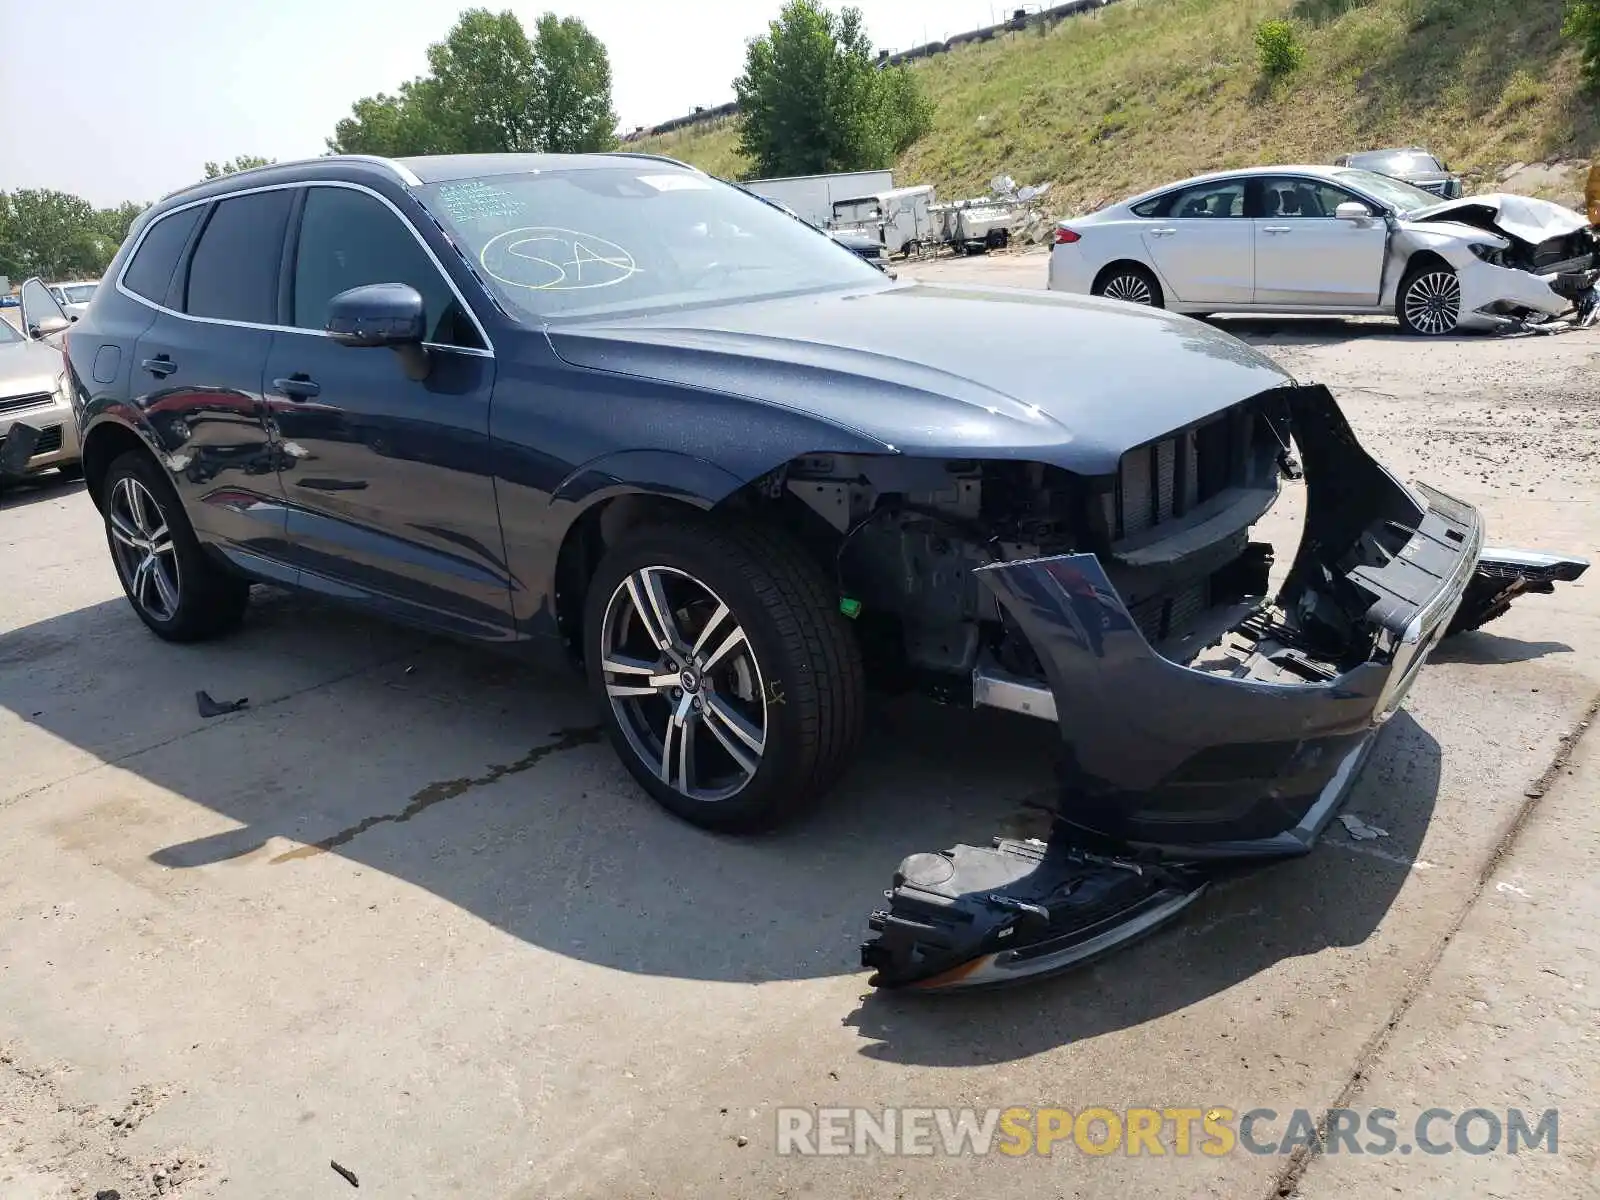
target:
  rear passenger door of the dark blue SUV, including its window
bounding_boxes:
[125,187,293,566]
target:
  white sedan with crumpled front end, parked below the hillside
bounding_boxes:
[1050,166,1600,336]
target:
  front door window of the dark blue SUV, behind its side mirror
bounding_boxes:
[293,187,483,349]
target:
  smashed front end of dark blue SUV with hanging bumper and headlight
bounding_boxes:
[838,384,1587,989]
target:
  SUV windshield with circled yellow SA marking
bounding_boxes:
[418,162,883,322]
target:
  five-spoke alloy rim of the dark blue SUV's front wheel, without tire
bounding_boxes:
[600,566,766,803]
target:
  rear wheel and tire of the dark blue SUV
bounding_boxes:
[102,451,250,642]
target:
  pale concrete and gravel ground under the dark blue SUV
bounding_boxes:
[0,254,1600,1200]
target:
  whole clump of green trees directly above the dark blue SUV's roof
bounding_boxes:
[328,8,616,157]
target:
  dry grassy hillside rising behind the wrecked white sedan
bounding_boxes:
[630,0,1600,211]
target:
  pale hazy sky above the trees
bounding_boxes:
[0,0,1018,206]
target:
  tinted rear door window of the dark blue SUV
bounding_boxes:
[184,189,293,325]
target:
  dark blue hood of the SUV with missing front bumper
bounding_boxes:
[546,283,1293,474]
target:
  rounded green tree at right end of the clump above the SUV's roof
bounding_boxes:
[533,13,616,154]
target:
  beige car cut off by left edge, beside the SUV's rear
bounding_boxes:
[0,305,82,483]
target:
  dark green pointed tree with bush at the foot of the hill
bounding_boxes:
[733,0,933,174]
